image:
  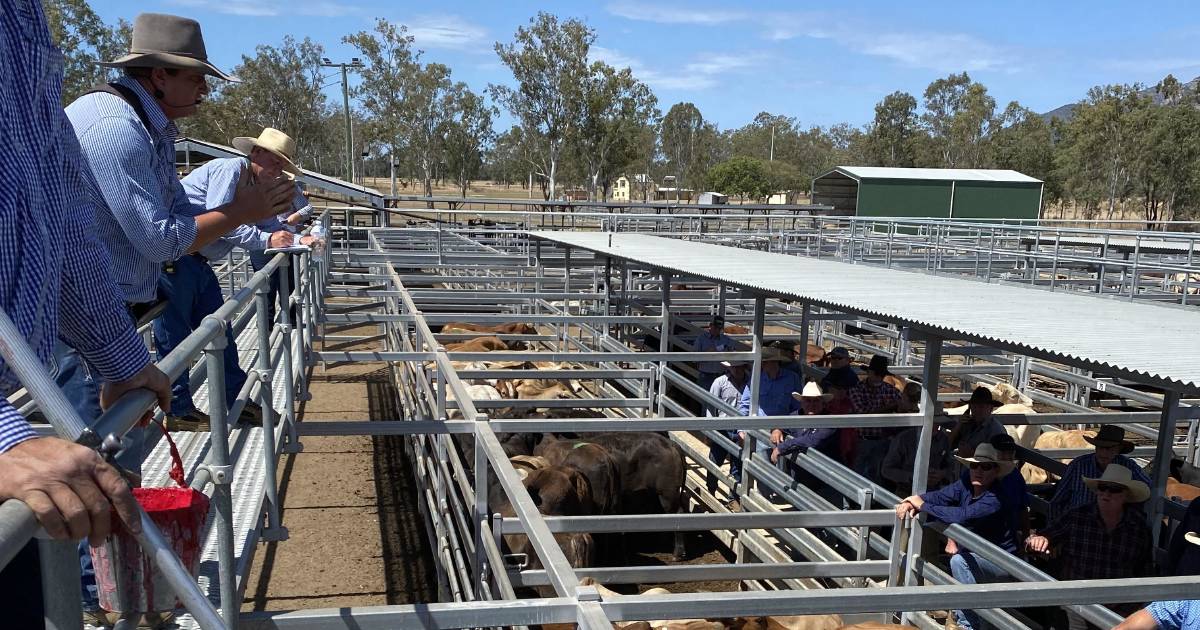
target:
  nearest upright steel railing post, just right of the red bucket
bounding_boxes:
[204,316,240,629]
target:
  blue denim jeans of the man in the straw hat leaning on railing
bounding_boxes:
[154,256,246,415]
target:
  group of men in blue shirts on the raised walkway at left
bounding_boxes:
[0,7,324,628]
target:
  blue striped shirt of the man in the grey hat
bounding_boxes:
[66,77,196,302]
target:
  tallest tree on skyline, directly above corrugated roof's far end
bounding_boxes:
[488,12,595,197]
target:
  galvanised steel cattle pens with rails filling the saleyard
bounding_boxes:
[0,199,1200,629]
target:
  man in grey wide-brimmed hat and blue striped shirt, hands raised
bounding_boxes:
[55,13,292,446]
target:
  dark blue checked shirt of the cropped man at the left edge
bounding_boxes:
[0,0,150,452]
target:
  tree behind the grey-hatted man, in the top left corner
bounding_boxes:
[42,0,133,103]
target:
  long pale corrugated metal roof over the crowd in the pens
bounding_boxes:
[530,232,1200,394]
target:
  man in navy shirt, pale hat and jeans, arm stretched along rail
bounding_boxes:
[896,443,1016,630]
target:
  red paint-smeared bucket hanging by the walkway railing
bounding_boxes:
[91,422,209,616]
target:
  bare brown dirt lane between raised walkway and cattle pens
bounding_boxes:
[242,329,437,611]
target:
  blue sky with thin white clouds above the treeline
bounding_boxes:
[92,0,1200,128]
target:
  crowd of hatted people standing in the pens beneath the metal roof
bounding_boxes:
[696,318,1200,630]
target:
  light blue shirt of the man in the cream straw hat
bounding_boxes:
[180,157,283,260]
